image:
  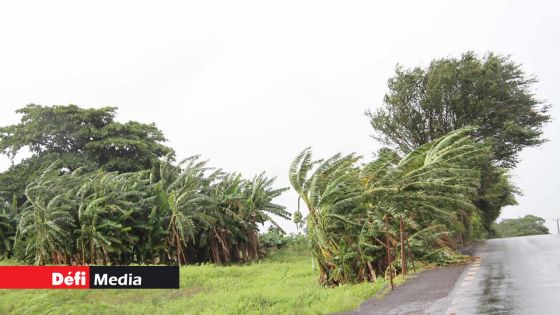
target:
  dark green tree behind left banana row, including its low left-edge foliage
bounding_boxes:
[0,104,173,210]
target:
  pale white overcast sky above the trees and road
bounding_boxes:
[0,0,560,232]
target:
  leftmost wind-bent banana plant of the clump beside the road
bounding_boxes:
[289,148,363,283]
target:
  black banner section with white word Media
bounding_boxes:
[89,266,179,289]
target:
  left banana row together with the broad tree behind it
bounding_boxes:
[0,105,290,265]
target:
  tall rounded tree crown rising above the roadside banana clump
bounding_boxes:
[366,52,550,168]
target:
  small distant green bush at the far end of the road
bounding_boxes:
[492,214,550,237]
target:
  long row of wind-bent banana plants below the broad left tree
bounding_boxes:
[0,156,289,265]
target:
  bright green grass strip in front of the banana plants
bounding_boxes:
[0,247,386,314]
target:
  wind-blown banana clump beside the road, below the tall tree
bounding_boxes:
[290,127,489,285]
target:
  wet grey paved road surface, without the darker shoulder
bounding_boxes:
[446,235,560,315]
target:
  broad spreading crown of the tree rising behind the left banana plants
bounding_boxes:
[0,104,172,172]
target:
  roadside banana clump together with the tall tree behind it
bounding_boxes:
[290,52,550,285]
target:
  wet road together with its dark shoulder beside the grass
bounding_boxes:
[350,235,560,315]
